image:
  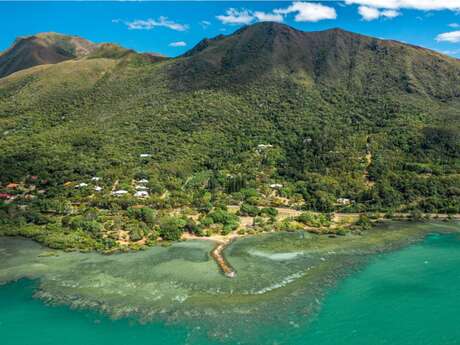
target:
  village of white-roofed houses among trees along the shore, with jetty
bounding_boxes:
[0,144,455,260]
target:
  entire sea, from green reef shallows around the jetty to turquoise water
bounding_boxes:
[0,224,460,345]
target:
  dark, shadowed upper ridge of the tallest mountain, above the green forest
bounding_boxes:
[174,22,460,98]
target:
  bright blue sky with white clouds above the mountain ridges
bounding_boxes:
[0,0,460,58]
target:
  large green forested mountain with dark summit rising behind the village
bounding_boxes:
[0,23,460,212]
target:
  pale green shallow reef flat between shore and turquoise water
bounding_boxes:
[0,222,460,320]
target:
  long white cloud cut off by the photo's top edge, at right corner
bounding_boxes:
[345,0,460,11]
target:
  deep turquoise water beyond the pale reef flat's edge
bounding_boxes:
[0,227,460,345]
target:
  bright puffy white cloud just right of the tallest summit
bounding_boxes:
[273,1,337,22]
